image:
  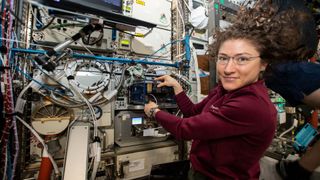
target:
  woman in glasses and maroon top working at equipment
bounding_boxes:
[144,1,284,180]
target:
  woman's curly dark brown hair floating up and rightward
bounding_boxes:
[210,0,315,63]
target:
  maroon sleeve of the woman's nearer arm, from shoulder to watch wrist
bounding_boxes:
[156,93,271,140]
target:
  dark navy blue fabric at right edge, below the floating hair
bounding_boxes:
[265,62,320,106]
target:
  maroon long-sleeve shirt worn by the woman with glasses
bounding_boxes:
[155,81,277,180]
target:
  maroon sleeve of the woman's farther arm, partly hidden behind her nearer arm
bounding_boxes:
[176,91,216,117]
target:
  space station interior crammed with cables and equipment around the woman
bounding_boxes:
[0,0,320,180]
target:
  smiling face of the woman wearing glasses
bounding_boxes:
[217,39,267,91]
